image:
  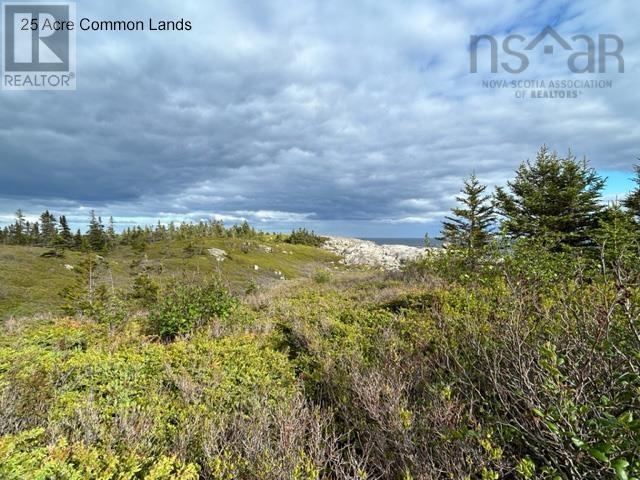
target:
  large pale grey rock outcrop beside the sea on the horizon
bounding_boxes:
[323,237,434,270]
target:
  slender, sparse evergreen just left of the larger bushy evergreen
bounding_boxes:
[440,174,495,251]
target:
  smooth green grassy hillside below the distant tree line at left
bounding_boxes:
[0,238,338,319]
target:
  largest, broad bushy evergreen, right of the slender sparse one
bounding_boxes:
[496,145,604,246]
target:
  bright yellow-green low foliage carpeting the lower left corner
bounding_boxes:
[0,319,296,479]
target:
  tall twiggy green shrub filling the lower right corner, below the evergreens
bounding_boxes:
[396,239,640,479]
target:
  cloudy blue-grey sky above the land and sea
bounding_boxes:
[0,0,640,237]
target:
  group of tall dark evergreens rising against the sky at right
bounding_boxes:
[440,146,640,253]
